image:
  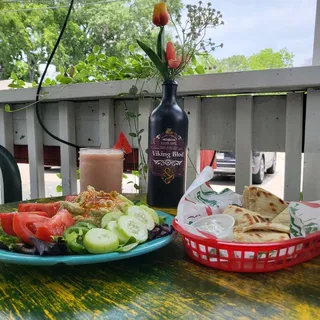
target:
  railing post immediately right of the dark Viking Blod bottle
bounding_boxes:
[184,97,201,188]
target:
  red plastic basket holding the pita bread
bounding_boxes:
[173,219,320,272]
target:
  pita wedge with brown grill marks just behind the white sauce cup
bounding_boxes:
[223,205,270,230]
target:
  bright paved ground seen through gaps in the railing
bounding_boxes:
[7,153,285,199]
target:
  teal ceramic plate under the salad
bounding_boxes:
[0,211,177,266]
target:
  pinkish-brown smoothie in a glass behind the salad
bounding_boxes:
[79,149,124,193]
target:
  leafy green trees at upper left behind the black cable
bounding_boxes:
[0,0,182,82]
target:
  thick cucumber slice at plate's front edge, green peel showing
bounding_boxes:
[83,228,119,253]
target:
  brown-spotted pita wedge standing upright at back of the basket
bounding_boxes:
[242,186,288,219]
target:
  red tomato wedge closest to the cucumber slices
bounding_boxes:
[36,209,75,242]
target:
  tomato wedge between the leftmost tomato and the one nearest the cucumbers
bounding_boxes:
[13,212,50,244]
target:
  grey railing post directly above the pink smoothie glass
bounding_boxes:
[99,99,115,148]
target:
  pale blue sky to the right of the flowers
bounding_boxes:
[183,0,316,67]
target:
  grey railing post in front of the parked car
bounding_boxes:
[235,96,253,194]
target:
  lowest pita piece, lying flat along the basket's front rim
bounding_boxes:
[233,230,290,243]
